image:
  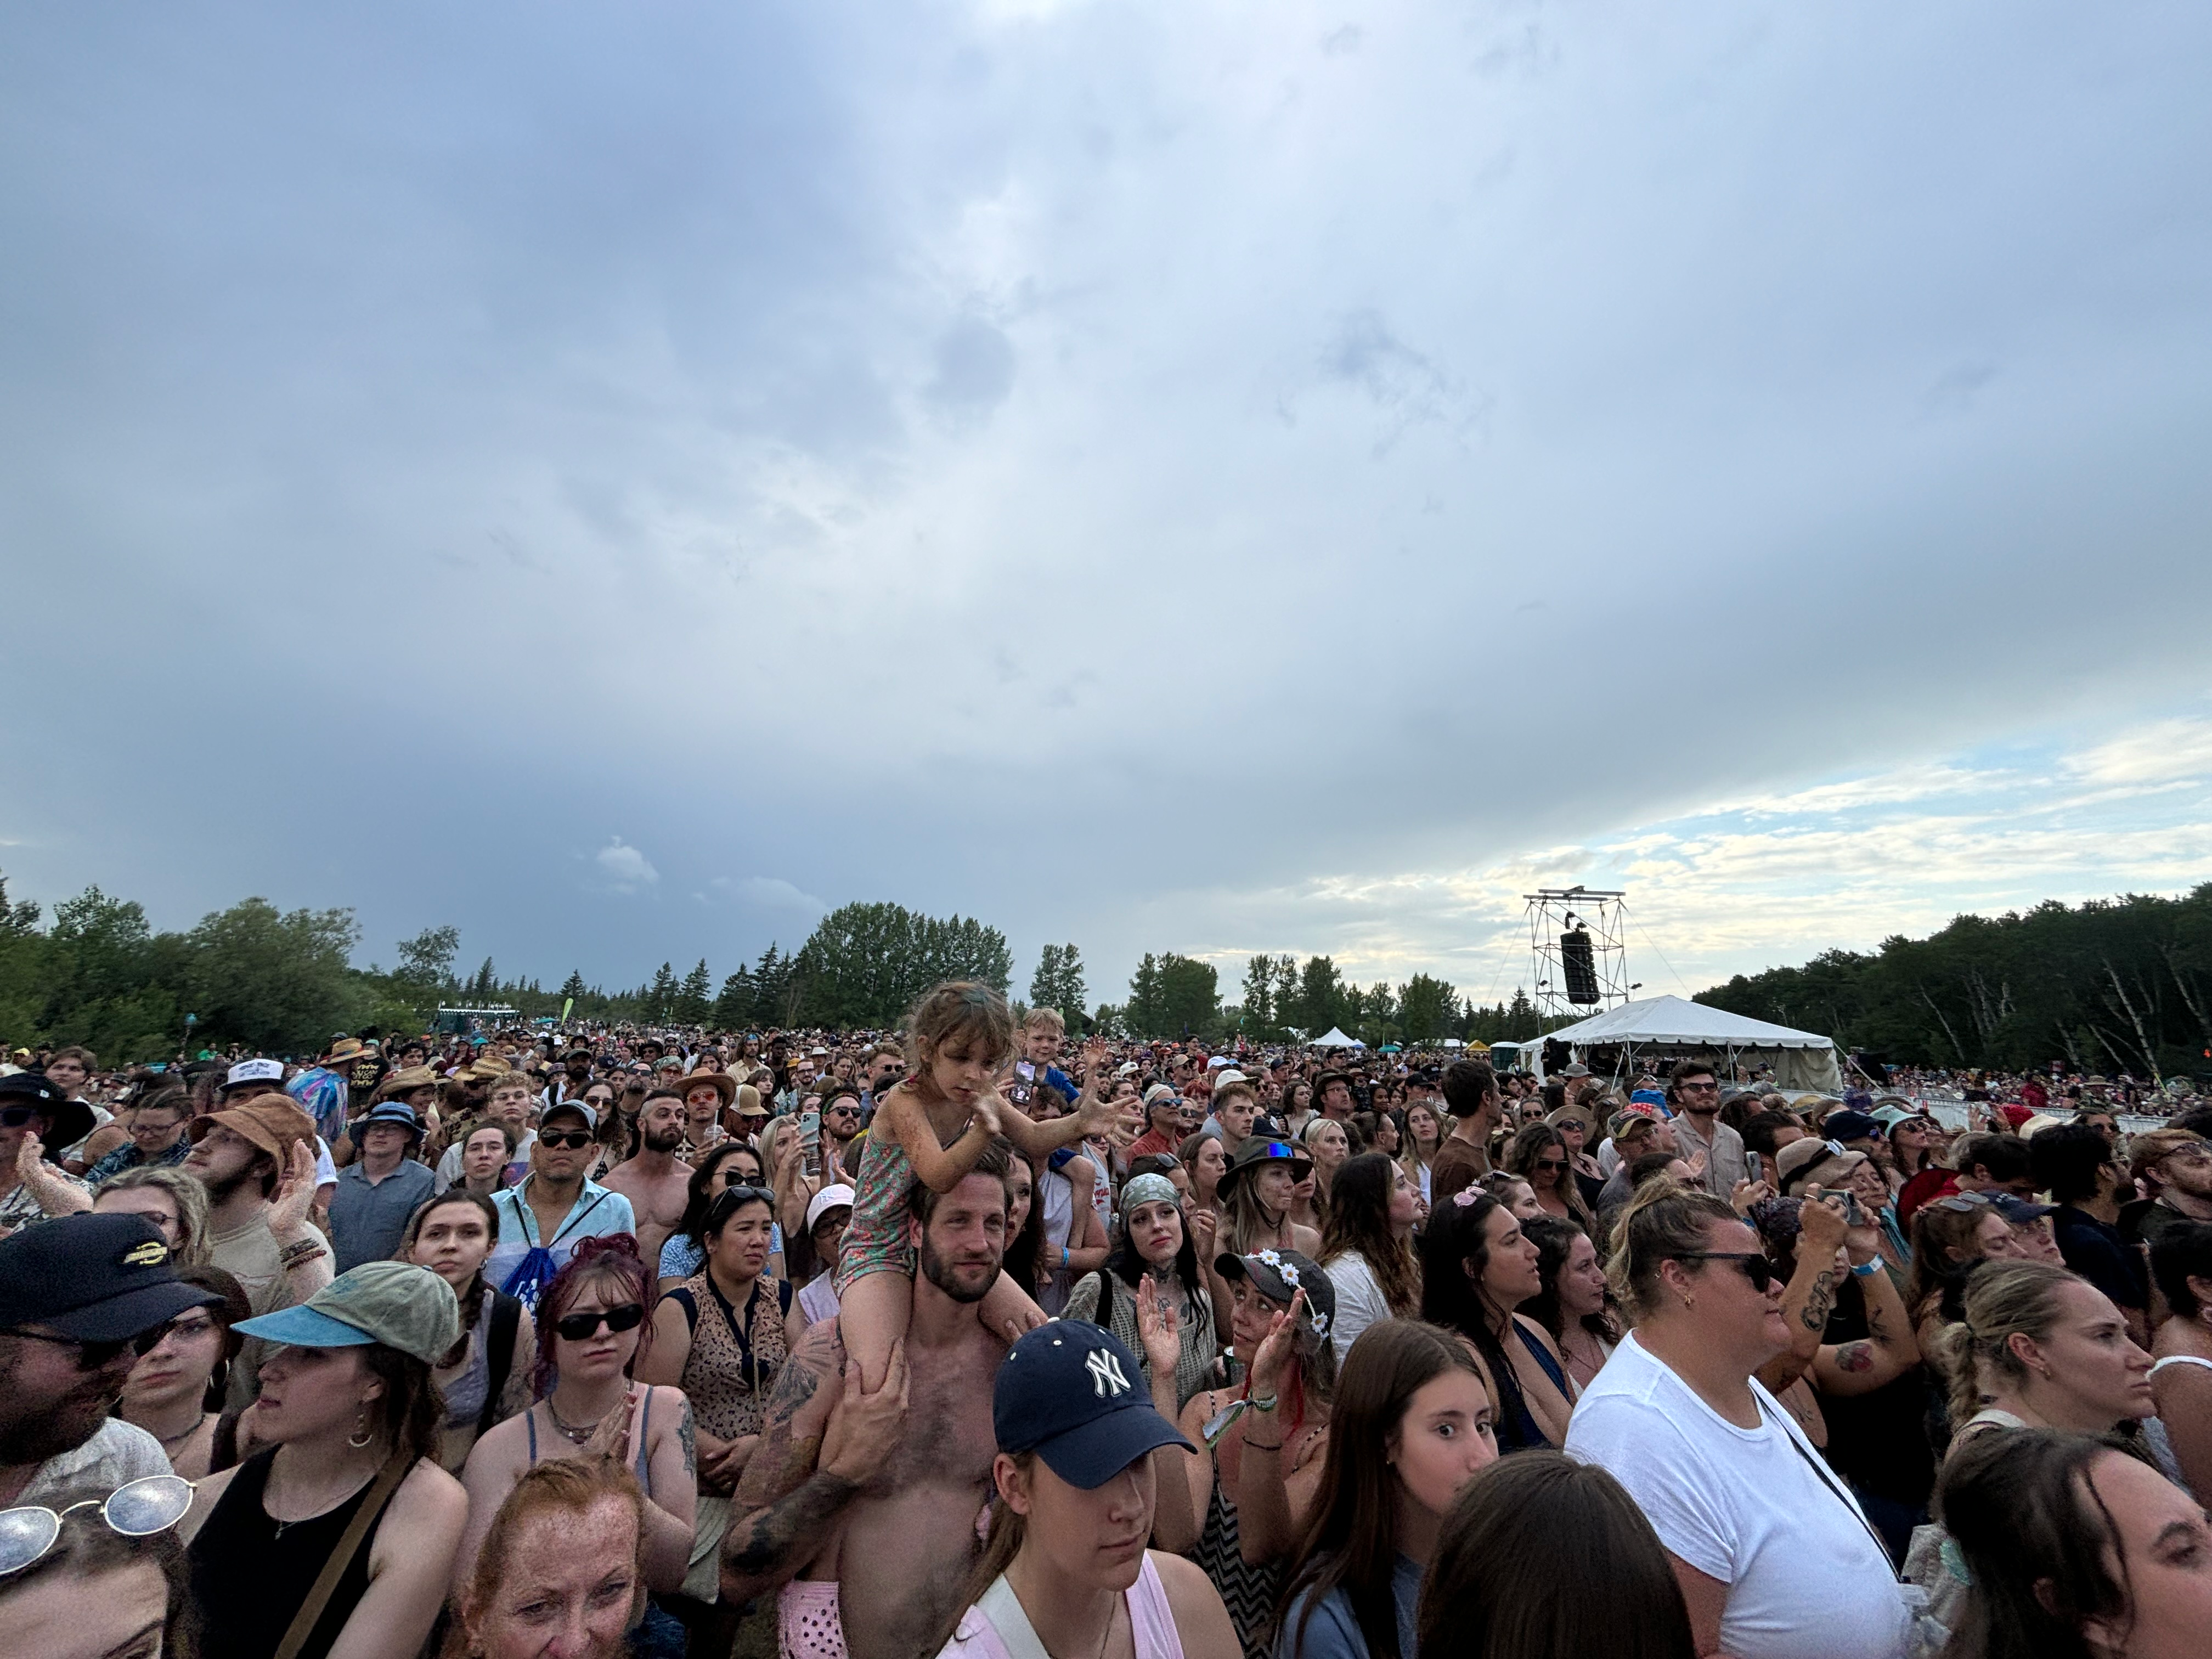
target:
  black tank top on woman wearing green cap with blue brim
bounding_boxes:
[186,1447,392,1659]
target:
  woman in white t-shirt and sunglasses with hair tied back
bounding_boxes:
[1566,1179,1914,1659]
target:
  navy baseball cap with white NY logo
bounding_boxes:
[991,1318,1197,1491]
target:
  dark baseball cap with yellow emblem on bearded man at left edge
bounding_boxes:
[0,1215,223,1342]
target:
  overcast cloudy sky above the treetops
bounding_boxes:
[0,0,2212,1013]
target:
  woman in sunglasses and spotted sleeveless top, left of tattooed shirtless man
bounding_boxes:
[637,1186,808,1637]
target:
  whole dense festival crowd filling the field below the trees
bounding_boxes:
[0,1000,2212,1659]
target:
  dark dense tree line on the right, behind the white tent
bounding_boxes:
[1697,883,2212,1077]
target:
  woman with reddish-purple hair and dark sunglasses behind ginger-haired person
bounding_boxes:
[452,1234,697,1626]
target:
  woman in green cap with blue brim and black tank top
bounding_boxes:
[182,1261,469,1659]
